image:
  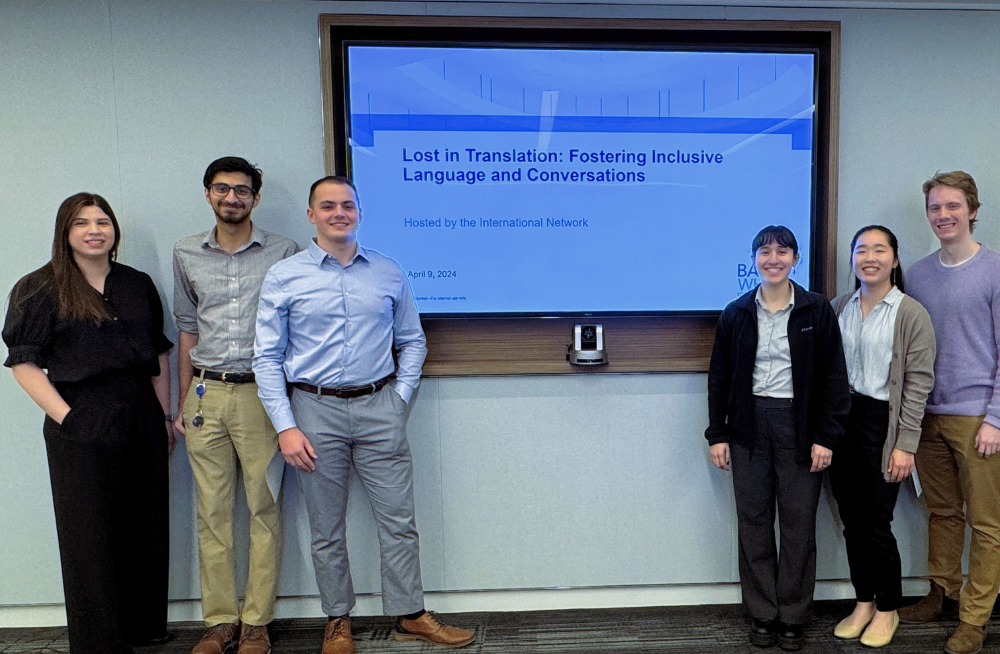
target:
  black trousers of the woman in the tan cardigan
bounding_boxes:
[830,393,903,611]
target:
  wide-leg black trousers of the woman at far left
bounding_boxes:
[43,377,169,654]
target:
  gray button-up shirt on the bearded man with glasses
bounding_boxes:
[174,225,299,372]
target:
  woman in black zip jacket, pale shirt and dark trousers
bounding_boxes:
[705,225,850,650]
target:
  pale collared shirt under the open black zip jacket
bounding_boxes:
[753,288,795,398]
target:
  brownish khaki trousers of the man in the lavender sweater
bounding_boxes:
[916,414,1000,626]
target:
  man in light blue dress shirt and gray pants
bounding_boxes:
[253,177,475,654]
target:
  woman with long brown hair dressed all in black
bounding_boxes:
[3,193,172,654]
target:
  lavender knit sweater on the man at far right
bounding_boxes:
[906,245,1000,428]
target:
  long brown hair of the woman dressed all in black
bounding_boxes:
[51,193,122,322]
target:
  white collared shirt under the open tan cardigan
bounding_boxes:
[837,286,903,401]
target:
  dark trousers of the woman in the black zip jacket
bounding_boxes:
[730,397,822,625]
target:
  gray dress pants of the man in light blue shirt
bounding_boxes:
[291,384,424,616]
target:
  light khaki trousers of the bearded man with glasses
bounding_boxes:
[184,377,281,626]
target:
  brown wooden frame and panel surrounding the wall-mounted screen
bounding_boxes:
[319,14,840,377]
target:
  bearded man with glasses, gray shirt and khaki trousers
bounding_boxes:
[174,157,299,654]
